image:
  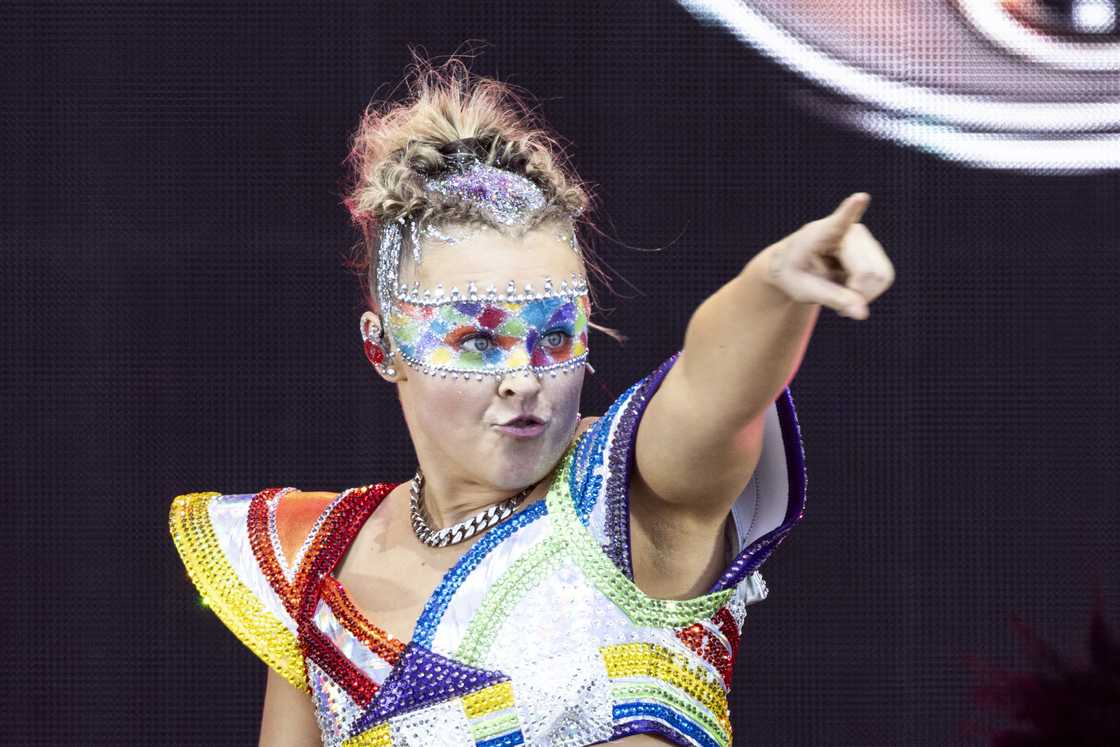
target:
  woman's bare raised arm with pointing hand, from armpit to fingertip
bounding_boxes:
[631,193,894,594]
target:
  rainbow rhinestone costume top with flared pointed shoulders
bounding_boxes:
[170,353,805,747]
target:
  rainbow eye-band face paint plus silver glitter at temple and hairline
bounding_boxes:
[375,155,590,381]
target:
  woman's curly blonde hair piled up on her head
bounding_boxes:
[343,50,625,343]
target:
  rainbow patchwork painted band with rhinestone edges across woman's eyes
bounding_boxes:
[389,293,590,380]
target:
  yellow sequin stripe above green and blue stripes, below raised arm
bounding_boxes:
[599,642,731,731]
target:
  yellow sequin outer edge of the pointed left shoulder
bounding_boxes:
[169,493,310,693]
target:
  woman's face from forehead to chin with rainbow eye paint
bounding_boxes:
[369,223,589,491]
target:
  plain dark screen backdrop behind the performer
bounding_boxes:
[0,1,1120,745]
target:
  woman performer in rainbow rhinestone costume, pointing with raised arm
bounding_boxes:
[170,54,894,747]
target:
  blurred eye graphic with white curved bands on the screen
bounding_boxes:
[680,0,1120,174]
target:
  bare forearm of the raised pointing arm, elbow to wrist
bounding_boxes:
[674,243,821,427]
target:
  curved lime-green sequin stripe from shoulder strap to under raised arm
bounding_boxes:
[544,449,734,627]
